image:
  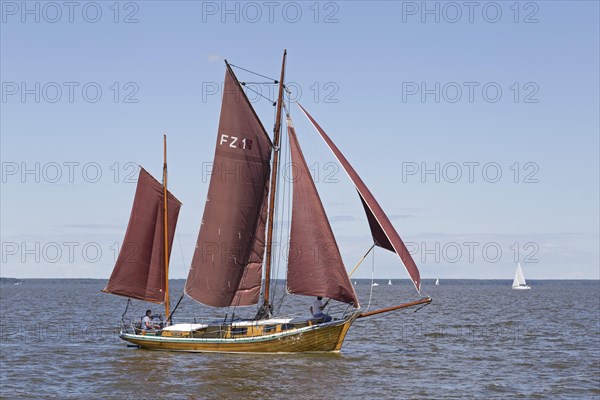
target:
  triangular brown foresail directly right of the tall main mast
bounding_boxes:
[287,118,359,308]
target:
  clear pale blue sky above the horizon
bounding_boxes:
[0,1,600,279]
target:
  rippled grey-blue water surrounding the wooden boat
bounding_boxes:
[0,280,600,399]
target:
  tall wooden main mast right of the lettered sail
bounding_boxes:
[263,50,287,312]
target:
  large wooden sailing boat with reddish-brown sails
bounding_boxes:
[104,51,431,353]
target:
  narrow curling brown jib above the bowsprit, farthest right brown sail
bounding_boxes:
[298,104,421,292]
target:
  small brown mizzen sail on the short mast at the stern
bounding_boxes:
[103,168,181,303]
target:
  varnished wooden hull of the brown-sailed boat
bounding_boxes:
[120,315,356,353]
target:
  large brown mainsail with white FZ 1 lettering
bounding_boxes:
[185,65,272,307]
